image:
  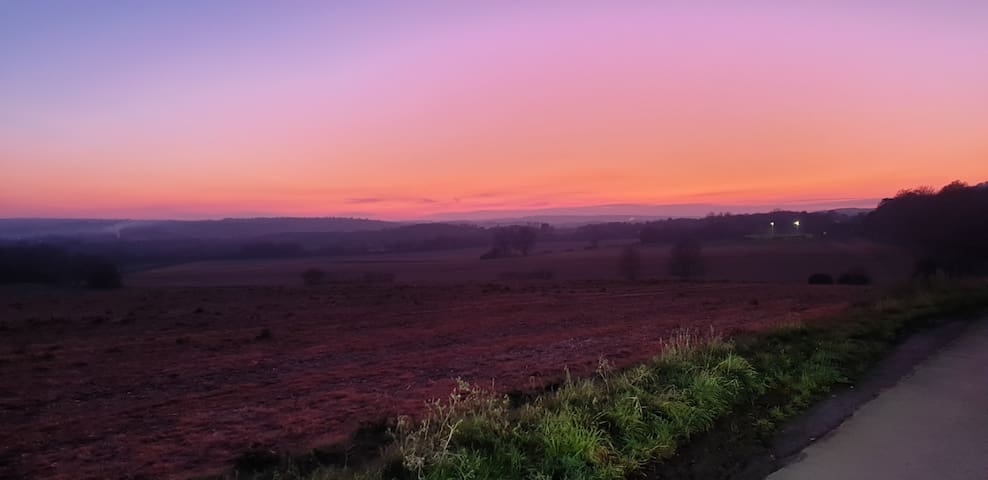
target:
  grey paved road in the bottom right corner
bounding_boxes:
[768,320,988,480]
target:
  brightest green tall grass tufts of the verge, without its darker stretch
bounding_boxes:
[382,333,761,479]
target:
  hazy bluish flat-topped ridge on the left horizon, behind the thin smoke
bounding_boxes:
[0,217,400,240]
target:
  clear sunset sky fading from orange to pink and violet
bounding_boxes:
[0,0,988,219]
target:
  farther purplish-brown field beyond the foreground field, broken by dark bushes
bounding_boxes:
[127,240,912,286]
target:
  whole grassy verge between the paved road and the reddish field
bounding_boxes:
[237,284,988,480]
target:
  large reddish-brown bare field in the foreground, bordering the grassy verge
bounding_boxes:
[0,281,875,479]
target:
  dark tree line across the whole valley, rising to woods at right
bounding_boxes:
[0,182,988,283]
